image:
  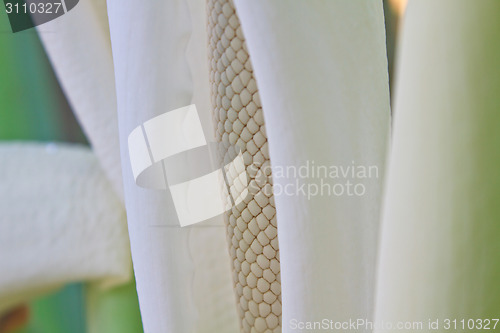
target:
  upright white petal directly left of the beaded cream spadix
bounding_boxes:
[108,0,238,333]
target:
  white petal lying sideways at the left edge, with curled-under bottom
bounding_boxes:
[0,143,131,312]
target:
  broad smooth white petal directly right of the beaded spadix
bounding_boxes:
[235,0,390,326]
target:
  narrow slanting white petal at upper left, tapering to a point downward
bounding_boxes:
[37,0,123,198]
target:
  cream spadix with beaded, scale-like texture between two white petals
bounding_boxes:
[207,0,281,332]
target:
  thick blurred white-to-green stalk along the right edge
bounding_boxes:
[376,0,500,326]
